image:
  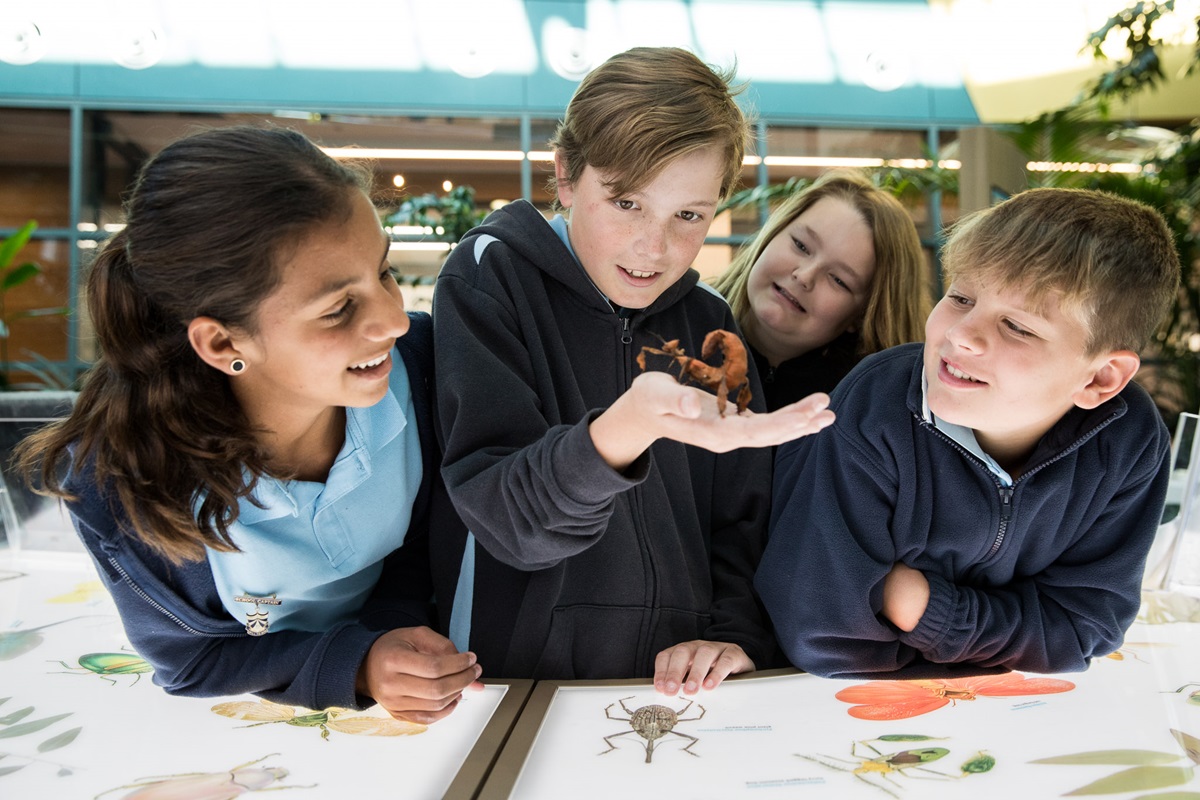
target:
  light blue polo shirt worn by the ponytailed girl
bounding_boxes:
[208,349,422,631]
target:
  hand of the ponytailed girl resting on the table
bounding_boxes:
[355,627,484,724]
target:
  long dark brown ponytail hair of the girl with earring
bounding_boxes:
[16,127,370,563]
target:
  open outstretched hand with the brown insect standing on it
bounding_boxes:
[590,372,834,471]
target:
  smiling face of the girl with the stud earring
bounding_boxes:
[233,190,408,419]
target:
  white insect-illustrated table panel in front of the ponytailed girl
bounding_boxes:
[0,554,528,800]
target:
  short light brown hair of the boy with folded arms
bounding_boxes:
[942,188,1180,355]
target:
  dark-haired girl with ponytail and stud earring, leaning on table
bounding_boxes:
[17,127,480,722]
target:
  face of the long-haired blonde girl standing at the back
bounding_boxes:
[745,197,875,365]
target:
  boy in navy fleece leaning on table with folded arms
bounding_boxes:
[755,188,1180,678]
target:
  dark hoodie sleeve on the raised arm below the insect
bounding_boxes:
[433,245,649,570]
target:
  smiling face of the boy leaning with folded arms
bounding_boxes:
[924,278,1108,468]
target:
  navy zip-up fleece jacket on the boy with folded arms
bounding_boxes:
[755,343,1170,678]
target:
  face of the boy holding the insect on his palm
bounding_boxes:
[554,146,725,308]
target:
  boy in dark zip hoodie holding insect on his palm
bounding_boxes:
[432,48,833,694]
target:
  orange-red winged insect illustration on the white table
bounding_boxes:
[834,672,1075,720]
